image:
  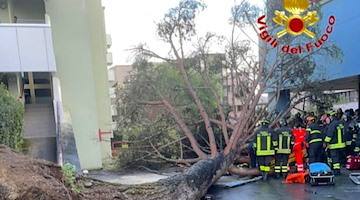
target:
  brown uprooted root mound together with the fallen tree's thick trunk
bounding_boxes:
[0,145,258,200]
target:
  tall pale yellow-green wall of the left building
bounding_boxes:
[45,0,111,169]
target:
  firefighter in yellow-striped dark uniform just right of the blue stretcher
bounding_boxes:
[324,111,345,175]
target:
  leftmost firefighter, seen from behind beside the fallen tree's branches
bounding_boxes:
[253,119,275,181]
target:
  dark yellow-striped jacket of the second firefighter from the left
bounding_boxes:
[273,126,294,154]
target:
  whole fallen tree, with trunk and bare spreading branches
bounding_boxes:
[1,0,344,199]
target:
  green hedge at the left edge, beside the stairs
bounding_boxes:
[0,83,24,149]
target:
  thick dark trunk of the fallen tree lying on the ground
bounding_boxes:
[82,154,232,200]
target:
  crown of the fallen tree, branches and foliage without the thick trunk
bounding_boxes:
[117,0,341,175]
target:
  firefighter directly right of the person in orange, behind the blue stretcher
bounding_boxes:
[306,116,323,164]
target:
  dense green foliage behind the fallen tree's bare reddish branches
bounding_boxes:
[115,59,221,169]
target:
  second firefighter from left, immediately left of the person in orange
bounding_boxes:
[273,118,294,178]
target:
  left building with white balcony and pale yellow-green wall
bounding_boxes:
[0,0,112,169]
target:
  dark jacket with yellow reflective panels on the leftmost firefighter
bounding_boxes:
[253,125,275,156]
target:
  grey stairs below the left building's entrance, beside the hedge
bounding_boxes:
[23,104,57,162]
